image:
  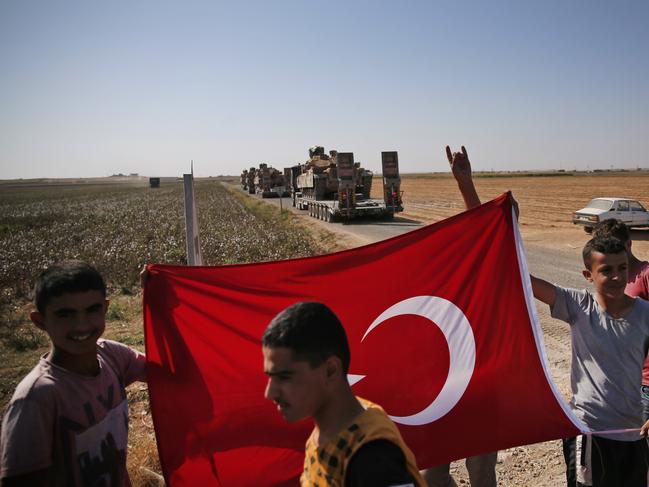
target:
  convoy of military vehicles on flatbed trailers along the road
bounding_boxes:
[241,146,403,221]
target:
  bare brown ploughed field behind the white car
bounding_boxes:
[372,171,649,254]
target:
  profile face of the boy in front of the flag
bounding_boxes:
[263,347,327,423]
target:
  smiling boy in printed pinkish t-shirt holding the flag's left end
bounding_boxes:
[0,261,145,487]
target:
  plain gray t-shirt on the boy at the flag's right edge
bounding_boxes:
[551,286,649,441]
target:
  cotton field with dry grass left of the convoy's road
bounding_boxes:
[0,180,326,486]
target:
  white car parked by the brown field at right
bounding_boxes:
[572,198,649,233]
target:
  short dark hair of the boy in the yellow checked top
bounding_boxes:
[262,302,351,374]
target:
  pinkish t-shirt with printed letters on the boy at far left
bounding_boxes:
[0,340,145,486]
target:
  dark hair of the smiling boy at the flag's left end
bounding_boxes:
[34,260,106,313]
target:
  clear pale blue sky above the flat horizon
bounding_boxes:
[0,0,649,179]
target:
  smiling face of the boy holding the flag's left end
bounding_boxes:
[30,290,108,355]
